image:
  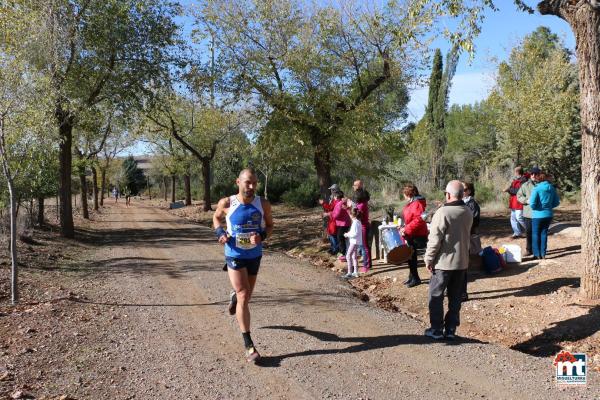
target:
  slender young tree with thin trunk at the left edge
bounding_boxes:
[0,2,55,304]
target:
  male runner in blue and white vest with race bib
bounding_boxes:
[213,168,273,361]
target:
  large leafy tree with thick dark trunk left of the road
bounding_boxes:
[27,0,177,237]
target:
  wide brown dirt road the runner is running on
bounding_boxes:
[49,203,600,399]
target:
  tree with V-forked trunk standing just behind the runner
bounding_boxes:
[147,26,253,211]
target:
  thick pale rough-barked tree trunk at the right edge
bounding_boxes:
[571,4,600,300]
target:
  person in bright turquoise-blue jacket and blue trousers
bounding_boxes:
[529,173,560,260]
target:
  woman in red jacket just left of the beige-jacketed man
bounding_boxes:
[400,184,429,287]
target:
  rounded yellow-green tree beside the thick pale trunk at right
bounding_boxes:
[489,27,581,179]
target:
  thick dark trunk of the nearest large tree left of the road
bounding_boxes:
[57,115,75,238]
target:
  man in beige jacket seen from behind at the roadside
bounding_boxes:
[425,181,473,339]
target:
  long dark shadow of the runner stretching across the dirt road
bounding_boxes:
[257,325,483,367]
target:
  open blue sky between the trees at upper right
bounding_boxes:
[408,0,575,121]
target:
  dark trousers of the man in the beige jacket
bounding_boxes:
[429,269,467,330]
